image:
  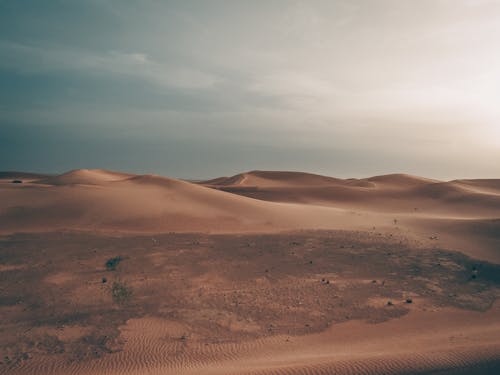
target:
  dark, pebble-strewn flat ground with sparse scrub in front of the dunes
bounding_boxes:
[0,231,500,372]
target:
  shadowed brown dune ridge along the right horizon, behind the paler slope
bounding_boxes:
[200,171,500,218]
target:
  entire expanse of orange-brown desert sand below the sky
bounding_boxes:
[0,170,500,374]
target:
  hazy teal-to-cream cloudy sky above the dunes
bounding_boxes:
[0,0,500,179]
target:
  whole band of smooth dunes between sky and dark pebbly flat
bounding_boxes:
[0,169,500,259]
